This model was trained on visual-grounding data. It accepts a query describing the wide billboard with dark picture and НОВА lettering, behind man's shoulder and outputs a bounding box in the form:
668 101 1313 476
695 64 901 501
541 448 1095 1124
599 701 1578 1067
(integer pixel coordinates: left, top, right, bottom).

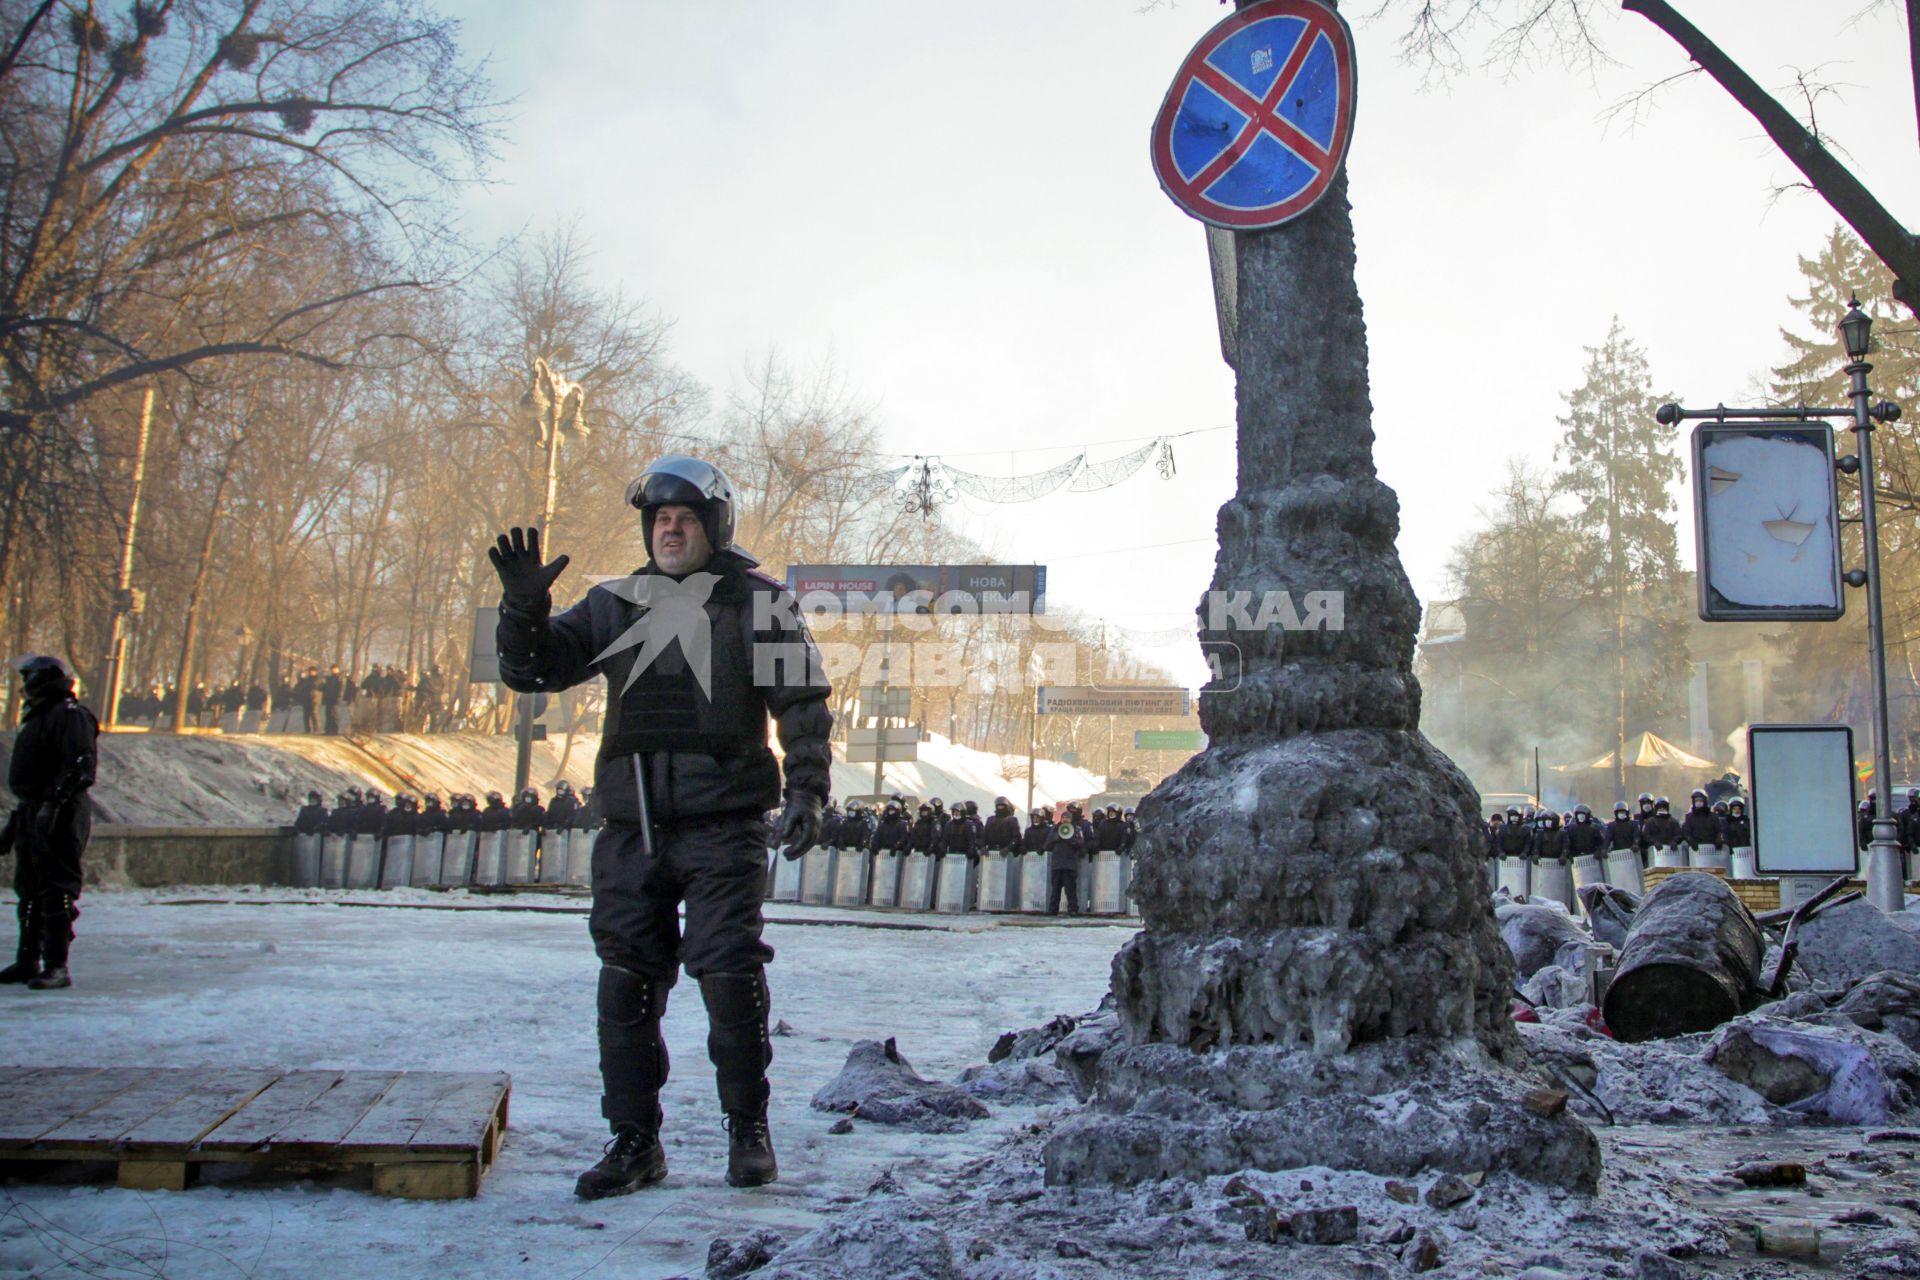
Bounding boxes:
787 564 1046 614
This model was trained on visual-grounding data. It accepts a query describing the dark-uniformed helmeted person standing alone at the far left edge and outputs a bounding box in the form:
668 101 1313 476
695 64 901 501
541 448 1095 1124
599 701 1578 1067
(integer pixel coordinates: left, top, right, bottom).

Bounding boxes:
0 654 100 990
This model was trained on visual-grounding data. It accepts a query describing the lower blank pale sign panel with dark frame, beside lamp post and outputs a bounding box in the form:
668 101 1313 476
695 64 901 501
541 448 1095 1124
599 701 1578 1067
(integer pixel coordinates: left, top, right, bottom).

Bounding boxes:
1747 723 1860 875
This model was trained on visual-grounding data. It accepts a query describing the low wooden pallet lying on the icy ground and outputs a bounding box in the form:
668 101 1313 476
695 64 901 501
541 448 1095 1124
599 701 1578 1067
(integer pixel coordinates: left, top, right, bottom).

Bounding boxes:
0 1067 513 1199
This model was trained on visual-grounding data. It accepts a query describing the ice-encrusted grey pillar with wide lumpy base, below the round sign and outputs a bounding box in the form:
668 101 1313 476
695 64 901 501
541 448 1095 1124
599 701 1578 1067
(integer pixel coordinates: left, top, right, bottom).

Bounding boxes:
1046 119 1599 1188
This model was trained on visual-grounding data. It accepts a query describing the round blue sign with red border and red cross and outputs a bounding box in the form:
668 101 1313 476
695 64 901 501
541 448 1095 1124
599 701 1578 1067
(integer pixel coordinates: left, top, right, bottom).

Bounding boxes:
1152 0 1357 230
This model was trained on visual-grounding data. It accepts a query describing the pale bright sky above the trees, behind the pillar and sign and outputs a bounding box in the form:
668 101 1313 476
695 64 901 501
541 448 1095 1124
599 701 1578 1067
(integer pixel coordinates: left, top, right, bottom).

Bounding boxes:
451 0 1916 683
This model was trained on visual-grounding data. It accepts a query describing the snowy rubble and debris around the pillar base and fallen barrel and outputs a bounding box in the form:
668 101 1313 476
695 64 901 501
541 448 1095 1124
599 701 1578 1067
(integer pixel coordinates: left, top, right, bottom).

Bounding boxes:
707 875 1920 1280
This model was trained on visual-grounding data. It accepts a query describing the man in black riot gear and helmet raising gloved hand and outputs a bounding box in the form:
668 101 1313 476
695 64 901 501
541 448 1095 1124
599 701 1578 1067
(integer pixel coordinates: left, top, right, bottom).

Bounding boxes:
490 457 833 1199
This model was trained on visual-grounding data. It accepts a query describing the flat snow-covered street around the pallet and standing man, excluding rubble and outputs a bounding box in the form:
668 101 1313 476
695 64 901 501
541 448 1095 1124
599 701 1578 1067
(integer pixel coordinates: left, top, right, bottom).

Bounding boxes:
0 889 1133 1280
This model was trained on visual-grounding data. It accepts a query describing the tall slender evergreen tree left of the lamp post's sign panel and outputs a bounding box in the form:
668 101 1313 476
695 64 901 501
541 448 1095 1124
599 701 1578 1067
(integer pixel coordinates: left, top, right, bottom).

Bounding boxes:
1553 317 1686 800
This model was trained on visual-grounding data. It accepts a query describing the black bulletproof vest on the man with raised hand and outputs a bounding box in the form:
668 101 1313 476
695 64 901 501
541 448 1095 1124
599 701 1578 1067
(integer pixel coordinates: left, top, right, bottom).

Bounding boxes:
599 572 766 760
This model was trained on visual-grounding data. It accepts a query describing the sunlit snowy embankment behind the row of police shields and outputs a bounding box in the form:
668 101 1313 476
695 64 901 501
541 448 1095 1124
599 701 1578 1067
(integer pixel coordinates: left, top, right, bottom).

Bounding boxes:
0 733 1106 827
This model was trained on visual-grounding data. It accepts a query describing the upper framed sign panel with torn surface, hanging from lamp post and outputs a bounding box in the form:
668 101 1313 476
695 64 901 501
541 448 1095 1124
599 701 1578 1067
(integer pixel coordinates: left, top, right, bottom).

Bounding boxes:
1693 422 1847 622
